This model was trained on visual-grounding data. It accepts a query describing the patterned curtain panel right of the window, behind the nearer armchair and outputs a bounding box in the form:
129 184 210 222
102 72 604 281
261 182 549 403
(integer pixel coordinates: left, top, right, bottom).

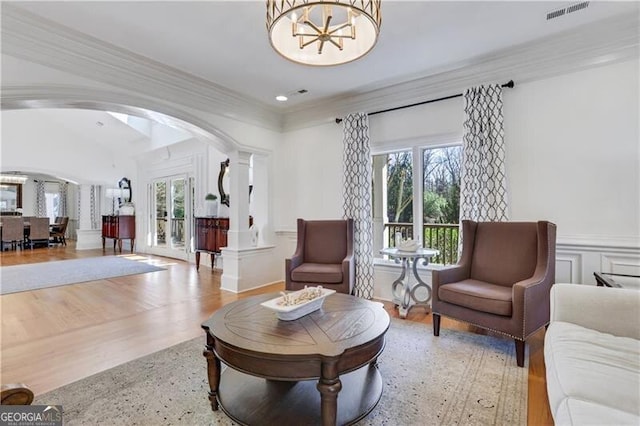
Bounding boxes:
460 85 509 223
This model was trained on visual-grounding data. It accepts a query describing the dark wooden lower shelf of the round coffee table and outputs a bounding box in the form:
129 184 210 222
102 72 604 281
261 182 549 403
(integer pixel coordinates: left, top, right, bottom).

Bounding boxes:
218 364 382 426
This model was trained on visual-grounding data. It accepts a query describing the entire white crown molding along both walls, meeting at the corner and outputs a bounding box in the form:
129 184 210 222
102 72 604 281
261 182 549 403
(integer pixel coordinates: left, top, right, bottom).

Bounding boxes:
1 2 640 131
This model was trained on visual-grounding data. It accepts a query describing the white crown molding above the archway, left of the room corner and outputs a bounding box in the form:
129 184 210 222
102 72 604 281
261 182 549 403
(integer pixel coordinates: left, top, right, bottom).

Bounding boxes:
2 3 281 130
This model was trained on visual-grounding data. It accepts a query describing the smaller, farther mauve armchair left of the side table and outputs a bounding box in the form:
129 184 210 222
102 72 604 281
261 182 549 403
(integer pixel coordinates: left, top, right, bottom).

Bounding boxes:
285 219 355 294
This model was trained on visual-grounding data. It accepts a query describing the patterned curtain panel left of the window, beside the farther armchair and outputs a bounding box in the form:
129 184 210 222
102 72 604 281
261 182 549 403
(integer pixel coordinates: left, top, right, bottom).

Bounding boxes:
342 113 373 299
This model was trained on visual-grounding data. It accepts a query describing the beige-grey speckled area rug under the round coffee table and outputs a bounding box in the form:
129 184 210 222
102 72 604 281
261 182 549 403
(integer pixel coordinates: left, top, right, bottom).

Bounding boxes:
34 319 528 426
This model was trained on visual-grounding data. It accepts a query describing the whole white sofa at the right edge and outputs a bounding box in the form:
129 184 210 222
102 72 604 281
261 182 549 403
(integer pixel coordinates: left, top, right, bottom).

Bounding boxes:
544 284 640 425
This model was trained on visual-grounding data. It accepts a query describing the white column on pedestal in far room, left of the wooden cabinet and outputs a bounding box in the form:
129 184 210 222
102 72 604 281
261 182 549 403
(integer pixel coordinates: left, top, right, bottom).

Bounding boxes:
76 185 102 250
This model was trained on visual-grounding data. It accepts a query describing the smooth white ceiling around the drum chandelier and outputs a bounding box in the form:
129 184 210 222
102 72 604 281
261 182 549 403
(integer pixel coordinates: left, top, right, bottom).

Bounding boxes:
12 0 639 110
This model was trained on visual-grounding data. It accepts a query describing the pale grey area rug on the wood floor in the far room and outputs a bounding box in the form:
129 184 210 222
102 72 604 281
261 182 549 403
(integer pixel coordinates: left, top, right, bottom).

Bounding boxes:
0 256 164 294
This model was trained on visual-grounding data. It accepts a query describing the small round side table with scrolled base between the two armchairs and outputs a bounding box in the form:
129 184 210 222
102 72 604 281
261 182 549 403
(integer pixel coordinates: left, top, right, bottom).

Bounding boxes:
380 248 440 318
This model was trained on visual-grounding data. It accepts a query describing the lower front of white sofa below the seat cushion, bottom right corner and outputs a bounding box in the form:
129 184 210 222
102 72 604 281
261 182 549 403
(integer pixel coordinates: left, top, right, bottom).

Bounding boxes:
553 398 640 426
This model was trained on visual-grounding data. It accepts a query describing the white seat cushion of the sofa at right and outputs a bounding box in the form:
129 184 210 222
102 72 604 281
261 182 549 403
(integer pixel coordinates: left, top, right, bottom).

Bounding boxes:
544 321 640 416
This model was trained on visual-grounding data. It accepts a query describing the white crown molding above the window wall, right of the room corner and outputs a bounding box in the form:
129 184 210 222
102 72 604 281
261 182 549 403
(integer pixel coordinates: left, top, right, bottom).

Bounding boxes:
283 14 640 131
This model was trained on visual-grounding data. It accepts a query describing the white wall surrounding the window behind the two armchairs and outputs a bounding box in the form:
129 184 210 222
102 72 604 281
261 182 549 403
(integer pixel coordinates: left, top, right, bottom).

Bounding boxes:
276 61 640 293
